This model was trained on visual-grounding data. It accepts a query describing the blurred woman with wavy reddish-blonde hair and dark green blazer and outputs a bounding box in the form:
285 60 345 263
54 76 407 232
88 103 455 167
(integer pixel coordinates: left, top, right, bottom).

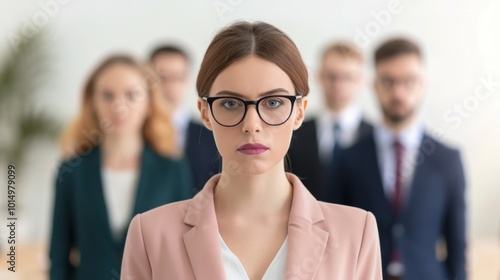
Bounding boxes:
50 55 192 280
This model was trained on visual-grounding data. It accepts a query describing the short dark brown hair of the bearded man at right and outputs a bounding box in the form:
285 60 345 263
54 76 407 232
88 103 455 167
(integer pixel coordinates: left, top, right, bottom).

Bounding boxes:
375 38 422 65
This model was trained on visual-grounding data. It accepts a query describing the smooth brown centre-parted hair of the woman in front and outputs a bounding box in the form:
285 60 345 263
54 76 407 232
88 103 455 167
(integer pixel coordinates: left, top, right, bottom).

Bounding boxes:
196 22 309 97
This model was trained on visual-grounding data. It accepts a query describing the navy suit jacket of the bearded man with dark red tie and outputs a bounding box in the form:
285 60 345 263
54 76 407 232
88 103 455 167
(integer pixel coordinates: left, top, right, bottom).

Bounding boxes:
330 134 466 280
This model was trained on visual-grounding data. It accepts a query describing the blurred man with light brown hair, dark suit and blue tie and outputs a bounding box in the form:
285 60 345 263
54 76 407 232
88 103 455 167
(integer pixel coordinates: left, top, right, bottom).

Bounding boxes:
288 42 371 200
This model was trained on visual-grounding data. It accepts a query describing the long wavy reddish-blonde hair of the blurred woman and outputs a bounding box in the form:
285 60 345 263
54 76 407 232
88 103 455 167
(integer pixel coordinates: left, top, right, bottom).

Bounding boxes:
61 55 179 158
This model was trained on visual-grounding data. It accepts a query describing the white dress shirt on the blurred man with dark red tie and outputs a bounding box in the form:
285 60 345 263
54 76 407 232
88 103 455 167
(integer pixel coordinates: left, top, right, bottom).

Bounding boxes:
374 123 424 198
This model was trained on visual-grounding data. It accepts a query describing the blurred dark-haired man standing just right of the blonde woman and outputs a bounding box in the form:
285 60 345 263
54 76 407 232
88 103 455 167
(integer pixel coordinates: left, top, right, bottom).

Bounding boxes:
150 45 220 193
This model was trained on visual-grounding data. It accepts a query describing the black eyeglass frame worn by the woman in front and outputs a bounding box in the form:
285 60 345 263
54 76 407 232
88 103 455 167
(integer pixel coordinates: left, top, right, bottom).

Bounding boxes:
201 95 304 127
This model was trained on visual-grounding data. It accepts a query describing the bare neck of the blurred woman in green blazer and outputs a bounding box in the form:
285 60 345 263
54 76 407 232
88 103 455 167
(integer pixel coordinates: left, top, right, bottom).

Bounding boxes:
101 134 144 169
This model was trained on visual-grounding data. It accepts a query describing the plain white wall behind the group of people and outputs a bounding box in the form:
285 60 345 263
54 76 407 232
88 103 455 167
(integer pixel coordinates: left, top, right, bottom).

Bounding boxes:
0 0 500 245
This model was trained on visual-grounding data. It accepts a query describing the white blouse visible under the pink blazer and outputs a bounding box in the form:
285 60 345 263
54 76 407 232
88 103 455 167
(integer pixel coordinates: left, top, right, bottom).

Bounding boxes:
219 234 288 280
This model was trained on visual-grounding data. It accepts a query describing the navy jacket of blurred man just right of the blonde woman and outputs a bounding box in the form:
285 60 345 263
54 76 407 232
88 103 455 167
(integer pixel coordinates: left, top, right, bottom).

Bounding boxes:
184 121 221 193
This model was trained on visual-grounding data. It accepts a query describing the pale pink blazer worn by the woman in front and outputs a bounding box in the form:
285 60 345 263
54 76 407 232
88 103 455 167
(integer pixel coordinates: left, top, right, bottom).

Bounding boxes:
121 173 382 280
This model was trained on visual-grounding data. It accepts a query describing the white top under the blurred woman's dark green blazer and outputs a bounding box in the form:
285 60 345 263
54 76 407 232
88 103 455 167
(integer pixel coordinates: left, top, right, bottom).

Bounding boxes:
102 168 139 240
